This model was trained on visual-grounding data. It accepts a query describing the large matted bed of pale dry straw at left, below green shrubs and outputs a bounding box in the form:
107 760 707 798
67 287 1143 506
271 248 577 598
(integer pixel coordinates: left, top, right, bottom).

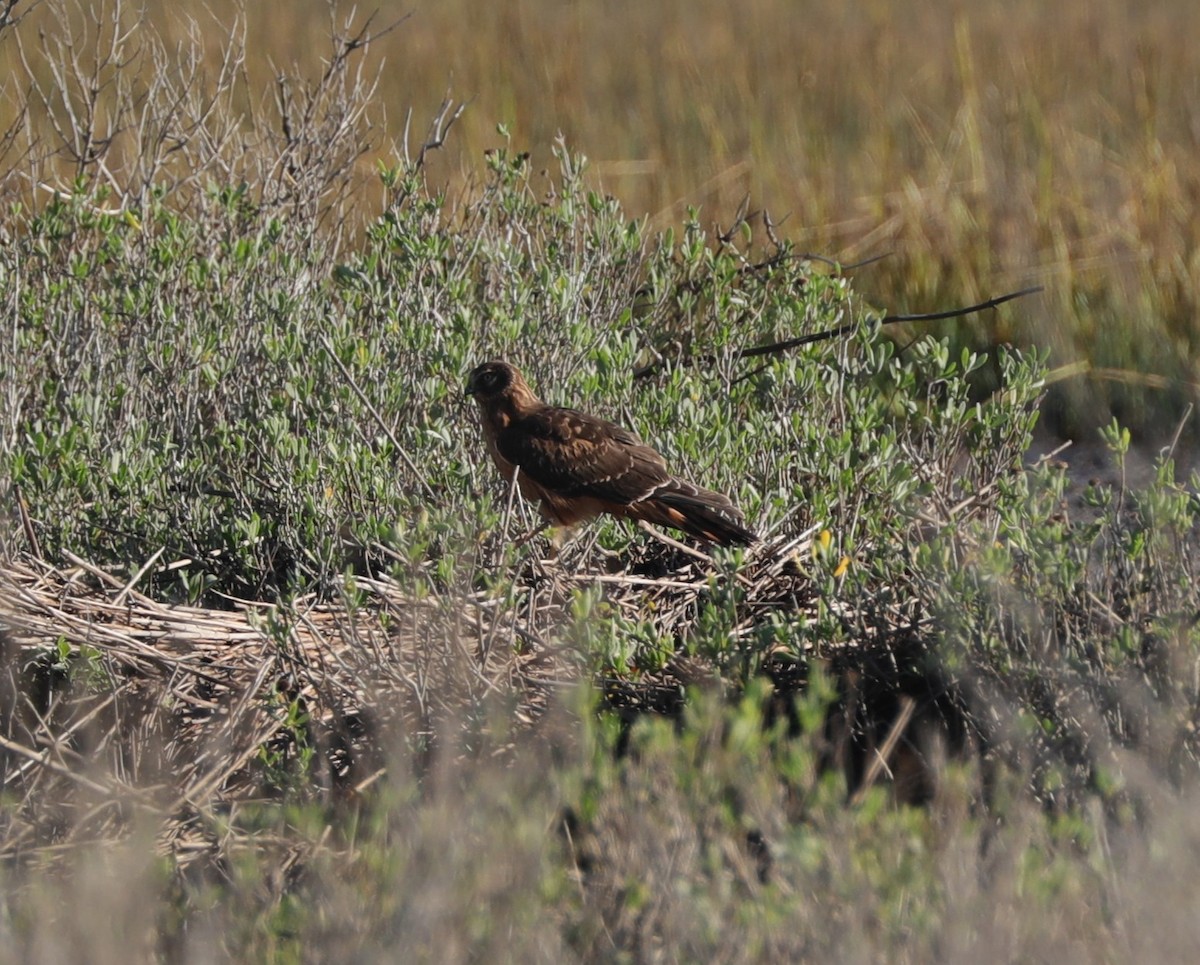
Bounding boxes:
0 549 572 865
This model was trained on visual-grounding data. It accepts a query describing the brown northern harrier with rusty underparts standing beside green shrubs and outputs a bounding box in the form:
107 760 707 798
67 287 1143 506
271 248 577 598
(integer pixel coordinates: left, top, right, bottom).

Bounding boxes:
467 361 757 546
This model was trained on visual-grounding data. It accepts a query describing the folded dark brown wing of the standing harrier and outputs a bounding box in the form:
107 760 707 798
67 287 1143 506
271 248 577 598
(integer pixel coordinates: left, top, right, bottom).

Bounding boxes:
496 406 671 505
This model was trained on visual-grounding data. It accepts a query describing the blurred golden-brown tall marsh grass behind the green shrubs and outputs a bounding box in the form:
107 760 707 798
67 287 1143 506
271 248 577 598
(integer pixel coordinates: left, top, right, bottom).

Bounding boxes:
9 0 1200 430
